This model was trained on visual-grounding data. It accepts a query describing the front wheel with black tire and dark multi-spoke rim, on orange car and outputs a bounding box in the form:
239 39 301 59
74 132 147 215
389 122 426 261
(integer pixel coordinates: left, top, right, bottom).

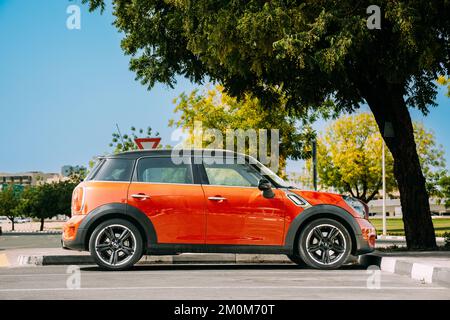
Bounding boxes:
297 218 352 270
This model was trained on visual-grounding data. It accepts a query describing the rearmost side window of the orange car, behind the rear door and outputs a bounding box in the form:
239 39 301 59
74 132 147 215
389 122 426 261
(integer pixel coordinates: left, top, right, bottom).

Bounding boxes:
92 159 134 181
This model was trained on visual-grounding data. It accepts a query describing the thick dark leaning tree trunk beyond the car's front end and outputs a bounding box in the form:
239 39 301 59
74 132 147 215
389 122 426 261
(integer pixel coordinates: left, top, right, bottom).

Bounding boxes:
366 83 436 249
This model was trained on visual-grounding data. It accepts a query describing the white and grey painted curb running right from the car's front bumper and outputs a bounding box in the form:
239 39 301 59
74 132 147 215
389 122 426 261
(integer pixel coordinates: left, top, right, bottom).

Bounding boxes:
359 254 450 287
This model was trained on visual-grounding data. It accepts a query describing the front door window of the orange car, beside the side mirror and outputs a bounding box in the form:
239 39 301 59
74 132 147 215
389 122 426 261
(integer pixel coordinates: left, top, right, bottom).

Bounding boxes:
204 163 262 187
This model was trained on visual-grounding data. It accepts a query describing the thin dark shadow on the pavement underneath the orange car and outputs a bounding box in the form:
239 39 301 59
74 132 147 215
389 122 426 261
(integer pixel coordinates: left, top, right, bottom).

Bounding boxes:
80 263 366 272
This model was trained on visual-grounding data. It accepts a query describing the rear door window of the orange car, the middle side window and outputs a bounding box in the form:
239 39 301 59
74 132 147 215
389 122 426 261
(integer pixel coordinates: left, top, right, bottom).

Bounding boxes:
137 158 193 184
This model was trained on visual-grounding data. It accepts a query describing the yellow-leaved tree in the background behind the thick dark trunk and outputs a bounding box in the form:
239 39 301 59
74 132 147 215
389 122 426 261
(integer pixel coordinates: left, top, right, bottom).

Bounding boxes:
318 113 446 202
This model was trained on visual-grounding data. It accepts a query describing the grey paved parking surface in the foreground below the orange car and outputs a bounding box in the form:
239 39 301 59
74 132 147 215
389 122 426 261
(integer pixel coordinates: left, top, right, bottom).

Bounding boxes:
0 264 450 300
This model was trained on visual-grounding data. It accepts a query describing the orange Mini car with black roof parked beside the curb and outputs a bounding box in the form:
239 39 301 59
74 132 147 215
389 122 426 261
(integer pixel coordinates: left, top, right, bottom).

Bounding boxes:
62 150 376 270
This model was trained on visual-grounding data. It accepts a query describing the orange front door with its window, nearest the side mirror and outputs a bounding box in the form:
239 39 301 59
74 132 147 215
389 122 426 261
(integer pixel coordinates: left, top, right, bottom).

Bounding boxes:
203 163 285 245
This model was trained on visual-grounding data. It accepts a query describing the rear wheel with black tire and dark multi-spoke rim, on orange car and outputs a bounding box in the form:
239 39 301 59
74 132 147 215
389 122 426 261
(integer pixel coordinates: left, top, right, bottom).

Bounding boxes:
89 219 143 270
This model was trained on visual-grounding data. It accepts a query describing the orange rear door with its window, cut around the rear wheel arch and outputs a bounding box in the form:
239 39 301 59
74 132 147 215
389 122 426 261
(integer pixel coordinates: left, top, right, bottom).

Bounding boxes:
128 157 206 244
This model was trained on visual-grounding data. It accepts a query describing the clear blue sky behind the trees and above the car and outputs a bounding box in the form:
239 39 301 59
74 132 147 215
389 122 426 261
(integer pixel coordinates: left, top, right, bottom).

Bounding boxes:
0 0 450 172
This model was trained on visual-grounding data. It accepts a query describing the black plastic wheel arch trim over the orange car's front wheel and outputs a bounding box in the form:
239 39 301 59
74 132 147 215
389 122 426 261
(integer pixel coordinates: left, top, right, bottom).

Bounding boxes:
285 204 361 254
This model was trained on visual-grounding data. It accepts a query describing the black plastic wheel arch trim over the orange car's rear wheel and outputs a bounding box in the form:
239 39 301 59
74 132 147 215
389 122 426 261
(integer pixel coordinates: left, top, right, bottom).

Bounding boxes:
77 203 157 250
